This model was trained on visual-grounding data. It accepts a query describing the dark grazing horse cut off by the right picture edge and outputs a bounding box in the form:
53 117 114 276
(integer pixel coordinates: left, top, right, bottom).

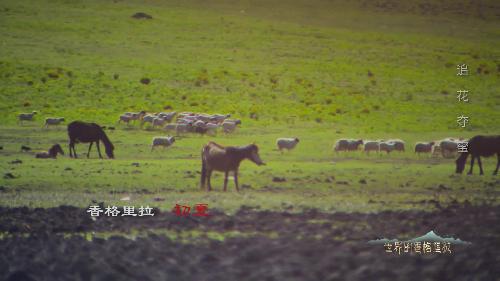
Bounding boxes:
456 135 500 175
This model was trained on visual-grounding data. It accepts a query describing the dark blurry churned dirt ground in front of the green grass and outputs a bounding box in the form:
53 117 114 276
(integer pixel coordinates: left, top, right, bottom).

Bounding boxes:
0 205 500 280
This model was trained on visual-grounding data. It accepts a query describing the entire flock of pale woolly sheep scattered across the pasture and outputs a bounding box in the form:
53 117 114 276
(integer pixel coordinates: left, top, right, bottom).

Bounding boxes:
18 111 465 158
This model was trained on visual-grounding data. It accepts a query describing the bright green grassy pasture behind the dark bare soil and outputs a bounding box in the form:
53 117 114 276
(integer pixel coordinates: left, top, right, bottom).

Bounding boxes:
0 0 500 212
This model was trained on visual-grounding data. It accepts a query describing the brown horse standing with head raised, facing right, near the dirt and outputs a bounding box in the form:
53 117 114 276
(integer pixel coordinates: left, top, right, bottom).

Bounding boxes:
201 142 265 191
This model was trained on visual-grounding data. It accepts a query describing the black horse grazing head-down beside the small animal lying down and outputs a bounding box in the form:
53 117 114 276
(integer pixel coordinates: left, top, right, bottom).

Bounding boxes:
68 121 115 158
